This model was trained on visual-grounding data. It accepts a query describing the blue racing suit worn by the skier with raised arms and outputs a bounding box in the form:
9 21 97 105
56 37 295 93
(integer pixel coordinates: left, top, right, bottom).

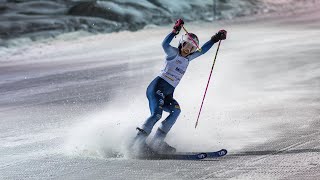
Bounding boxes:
142 33 214 142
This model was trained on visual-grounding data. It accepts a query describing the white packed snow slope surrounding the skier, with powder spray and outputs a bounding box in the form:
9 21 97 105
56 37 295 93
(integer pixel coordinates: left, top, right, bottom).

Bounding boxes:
0 3 320 179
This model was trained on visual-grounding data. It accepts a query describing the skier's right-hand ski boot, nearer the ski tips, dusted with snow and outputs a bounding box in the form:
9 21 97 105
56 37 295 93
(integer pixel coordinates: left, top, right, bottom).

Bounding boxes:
150 128 176 154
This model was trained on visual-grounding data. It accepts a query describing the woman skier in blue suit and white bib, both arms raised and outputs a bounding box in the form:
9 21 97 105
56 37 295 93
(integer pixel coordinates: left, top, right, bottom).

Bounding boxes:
134 19 227 153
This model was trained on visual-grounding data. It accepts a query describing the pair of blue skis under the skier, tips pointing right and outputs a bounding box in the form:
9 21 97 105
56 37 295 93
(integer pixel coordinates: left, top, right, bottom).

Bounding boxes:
140 149 228 160
